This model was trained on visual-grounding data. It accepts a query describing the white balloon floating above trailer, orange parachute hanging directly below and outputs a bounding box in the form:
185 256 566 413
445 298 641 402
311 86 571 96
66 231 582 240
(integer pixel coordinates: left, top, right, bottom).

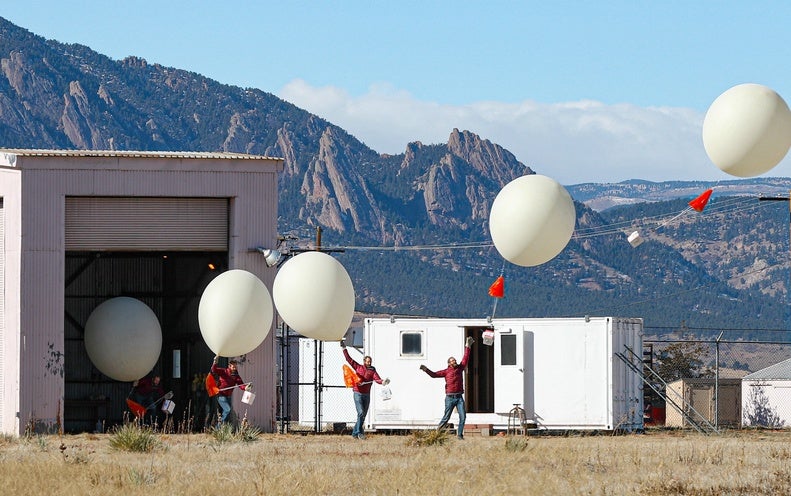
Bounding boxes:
489 174 576 267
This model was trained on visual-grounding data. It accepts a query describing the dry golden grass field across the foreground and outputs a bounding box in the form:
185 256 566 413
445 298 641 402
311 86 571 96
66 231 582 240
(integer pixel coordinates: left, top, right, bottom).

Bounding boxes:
0 431 791 496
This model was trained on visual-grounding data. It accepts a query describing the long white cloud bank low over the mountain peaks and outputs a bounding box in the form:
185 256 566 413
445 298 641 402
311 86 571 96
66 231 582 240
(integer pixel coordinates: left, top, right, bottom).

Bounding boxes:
279 80 791 184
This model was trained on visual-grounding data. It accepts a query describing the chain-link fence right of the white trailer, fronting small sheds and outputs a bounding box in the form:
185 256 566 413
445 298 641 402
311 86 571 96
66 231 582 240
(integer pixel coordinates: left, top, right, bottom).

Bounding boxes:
643 333 791 428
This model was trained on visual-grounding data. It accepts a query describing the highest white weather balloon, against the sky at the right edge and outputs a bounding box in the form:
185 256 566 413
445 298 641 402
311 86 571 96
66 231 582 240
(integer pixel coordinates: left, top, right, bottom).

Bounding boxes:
703 83 791 177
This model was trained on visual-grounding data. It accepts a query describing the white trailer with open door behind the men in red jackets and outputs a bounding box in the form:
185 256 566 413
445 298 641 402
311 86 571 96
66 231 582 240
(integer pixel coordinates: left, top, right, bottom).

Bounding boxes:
364 317 643 431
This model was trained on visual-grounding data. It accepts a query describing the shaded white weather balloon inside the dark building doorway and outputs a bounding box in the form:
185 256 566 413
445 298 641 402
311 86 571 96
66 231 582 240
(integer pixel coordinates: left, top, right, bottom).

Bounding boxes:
85 296 162 381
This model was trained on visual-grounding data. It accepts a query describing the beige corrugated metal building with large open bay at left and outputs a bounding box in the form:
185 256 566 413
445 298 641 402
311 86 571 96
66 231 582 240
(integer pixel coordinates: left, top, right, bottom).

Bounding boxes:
0 149 283 435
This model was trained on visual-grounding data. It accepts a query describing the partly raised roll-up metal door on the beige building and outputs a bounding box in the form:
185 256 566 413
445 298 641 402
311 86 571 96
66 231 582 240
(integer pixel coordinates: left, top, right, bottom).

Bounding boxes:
66 197 228 251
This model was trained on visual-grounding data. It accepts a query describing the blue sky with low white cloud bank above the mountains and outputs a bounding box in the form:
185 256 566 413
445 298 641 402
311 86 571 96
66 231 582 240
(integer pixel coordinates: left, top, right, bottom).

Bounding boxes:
0 0 791 184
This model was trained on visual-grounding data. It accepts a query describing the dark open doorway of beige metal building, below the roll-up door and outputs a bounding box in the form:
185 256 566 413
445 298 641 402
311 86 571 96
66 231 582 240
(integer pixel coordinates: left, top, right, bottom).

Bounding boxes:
64 252 228 432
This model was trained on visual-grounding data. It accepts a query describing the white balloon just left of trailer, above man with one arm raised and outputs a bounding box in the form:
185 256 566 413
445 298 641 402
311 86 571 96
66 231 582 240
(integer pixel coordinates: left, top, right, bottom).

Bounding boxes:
272 251 354 341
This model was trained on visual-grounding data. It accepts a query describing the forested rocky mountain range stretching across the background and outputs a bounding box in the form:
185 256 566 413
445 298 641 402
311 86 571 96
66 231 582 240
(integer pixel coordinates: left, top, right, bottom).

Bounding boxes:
0 18 791 334
